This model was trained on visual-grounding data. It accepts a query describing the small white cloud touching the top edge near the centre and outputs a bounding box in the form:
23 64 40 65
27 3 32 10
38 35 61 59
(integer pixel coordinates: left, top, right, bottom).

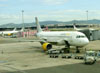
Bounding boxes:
43 0 68 5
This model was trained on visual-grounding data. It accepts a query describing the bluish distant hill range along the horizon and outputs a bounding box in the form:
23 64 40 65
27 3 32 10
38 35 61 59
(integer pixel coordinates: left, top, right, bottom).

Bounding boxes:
0 19 100 28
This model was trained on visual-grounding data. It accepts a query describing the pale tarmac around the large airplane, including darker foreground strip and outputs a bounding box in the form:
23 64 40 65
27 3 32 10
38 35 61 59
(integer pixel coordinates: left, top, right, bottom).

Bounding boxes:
0 38 100 73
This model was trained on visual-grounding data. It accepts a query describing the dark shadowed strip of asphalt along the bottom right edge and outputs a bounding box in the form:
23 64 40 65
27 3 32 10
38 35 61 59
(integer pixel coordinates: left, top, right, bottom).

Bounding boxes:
6 62 100 73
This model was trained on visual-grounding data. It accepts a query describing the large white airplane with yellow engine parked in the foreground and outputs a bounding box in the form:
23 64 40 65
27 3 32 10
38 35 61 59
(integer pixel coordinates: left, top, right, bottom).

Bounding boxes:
35 17 89 52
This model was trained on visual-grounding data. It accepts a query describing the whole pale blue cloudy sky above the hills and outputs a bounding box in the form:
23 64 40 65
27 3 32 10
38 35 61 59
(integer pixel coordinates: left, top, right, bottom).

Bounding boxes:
0 0 100 25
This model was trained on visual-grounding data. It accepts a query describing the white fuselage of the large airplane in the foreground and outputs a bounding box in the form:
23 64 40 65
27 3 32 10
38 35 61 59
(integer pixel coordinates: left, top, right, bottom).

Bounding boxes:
37 31 89 46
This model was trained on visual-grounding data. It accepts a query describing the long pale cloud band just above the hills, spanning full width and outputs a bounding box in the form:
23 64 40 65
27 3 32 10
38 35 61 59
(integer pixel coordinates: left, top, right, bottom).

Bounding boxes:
0 10 100 24
